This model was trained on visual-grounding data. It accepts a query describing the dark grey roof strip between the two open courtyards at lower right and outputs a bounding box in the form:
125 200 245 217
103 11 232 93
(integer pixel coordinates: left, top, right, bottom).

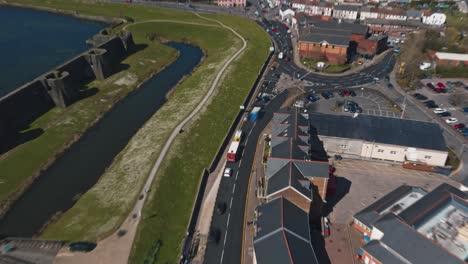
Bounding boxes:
399 183 468 226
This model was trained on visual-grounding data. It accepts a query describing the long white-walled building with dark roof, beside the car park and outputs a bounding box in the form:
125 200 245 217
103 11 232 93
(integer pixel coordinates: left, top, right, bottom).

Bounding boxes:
309 114 448 166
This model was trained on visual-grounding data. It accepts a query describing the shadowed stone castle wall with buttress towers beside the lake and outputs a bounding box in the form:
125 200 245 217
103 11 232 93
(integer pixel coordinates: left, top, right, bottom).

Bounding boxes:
0 29 135 148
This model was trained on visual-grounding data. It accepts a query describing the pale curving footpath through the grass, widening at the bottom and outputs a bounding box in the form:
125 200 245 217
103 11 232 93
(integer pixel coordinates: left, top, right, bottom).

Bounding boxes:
54 13 247 264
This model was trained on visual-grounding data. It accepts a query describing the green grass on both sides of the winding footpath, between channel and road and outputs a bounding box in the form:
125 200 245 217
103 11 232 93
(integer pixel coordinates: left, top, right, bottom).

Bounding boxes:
6 0 271 263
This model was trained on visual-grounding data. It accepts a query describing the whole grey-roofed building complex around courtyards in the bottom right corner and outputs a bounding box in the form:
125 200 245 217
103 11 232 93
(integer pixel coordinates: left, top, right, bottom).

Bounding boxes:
354 183 468 264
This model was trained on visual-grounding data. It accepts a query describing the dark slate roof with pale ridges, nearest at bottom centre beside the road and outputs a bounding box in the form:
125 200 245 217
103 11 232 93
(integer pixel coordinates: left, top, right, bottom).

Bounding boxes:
254 197 318 264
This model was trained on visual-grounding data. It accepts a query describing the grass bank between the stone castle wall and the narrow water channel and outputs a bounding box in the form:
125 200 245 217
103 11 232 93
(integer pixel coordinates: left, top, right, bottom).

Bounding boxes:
0 1 178 204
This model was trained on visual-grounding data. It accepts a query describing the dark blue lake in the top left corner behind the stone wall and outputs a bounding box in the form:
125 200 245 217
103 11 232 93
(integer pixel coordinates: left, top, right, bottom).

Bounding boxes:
0 7 105 97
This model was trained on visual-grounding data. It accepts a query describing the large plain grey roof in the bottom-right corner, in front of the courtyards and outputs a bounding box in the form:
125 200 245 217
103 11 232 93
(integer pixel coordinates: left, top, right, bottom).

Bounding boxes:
373 213 464 264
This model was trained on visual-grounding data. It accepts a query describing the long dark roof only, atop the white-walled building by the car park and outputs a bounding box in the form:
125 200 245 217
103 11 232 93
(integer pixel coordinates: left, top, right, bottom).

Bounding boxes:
309 113 447 151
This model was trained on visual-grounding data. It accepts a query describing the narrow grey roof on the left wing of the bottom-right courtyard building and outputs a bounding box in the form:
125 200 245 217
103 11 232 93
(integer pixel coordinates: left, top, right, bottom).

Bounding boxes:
354 185 425 228
